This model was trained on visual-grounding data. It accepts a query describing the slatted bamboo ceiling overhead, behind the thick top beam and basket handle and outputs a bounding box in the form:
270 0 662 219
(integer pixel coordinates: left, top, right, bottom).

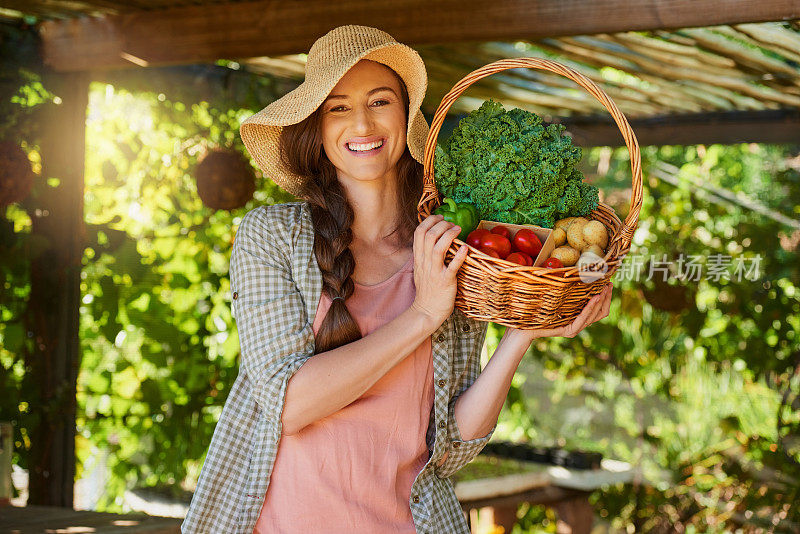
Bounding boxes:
0 0 800 123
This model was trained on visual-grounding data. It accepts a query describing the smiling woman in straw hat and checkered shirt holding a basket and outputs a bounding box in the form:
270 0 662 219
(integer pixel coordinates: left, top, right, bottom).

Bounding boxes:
182 26 610 534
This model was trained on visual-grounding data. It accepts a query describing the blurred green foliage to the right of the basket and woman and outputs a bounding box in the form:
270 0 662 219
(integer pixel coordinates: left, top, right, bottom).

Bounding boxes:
490 144 800 532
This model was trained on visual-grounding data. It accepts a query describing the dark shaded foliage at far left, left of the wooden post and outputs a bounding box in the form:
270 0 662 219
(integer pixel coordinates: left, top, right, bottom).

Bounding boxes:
0 19 58 486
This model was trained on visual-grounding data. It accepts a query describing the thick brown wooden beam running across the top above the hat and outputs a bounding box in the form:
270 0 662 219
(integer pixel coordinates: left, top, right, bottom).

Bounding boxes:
40 0 800 71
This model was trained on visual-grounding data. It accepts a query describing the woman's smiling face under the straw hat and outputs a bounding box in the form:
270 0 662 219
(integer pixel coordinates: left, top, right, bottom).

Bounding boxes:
320 60 407 189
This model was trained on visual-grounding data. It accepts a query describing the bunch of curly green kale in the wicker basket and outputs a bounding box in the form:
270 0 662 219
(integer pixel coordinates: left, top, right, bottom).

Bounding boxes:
434 100 598 228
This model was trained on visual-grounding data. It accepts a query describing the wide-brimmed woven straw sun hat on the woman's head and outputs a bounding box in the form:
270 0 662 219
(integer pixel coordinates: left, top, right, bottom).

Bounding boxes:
239 25 428 196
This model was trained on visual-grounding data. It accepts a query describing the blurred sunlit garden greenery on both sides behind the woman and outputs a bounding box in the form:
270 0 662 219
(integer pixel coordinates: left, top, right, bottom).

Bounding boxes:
0 5 800 534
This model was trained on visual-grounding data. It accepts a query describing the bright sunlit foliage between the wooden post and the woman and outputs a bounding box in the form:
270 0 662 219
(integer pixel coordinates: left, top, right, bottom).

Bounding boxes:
78 84 294 510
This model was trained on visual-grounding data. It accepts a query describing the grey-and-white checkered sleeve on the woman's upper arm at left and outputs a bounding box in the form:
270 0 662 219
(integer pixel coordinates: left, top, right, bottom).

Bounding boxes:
230 206 314 426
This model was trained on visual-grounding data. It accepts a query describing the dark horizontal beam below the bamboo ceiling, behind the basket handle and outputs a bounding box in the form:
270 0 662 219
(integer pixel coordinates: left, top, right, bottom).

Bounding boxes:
434 109 800 147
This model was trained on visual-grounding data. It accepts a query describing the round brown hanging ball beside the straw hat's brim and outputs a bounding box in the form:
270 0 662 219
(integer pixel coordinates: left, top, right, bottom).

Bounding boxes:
195 148 256 214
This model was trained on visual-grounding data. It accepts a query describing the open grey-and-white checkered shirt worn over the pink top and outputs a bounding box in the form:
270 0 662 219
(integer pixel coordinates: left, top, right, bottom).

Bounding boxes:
181 202 496 534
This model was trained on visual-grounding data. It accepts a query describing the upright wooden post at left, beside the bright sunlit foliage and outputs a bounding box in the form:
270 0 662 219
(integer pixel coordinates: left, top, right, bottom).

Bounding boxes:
26 72 89 508
